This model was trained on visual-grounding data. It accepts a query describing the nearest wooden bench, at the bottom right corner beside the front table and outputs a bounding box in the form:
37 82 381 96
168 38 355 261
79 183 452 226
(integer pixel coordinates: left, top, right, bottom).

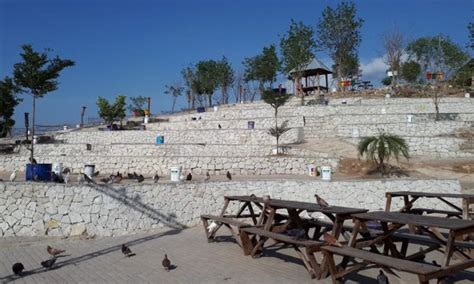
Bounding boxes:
321 246 474 283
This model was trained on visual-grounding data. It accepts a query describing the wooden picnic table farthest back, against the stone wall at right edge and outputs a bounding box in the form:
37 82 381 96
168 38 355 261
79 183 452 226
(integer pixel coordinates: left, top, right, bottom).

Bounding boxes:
385 191 474 220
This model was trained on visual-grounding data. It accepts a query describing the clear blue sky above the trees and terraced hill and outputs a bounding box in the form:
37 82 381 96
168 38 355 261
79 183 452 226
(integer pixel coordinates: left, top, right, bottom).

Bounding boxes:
0 0 473 126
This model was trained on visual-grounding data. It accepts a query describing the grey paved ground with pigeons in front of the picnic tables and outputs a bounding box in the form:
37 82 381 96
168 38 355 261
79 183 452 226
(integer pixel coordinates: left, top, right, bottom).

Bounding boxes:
0 226 474 284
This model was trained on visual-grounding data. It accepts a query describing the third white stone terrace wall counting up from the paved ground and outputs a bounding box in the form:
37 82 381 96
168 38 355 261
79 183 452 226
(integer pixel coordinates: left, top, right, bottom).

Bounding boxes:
52 127 303 145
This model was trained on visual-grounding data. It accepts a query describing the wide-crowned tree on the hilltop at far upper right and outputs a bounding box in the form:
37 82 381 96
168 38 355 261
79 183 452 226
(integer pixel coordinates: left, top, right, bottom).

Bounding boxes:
406 35 469 120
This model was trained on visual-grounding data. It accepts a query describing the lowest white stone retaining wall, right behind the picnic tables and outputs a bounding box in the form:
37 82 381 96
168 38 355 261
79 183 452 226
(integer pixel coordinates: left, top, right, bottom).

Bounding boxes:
0 179 461 237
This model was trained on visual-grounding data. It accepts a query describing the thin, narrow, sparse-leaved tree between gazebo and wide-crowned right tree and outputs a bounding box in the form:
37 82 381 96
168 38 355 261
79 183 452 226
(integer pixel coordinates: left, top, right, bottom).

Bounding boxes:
383 30 404 87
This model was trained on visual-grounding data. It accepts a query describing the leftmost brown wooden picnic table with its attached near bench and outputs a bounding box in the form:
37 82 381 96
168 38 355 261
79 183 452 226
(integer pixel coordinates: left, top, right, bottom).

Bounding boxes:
230 196 368 278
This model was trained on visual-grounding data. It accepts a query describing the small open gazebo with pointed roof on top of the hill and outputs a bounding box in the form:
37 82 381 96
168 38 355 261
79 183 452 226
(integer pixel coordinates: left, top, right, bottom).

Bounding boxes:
290 58 333 95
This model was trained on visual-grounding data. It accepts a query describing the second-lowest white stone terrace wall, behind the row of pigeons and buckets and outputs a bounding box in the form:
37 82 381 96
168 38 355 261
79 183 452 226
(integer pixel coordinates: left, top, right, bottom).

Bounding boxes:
0 152 339 176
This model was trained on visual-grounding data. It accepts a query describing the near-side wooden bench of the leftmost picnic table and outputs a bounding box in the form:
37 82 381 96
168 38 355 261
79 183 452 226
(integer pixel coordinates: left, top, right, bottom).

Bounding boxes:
240 227 324 278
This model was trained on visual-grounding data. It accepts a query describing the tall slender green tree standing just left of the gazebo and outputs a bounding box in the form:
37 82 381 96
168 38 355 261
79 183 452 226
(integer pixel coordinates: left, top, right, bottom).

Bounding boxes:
280 20 316 105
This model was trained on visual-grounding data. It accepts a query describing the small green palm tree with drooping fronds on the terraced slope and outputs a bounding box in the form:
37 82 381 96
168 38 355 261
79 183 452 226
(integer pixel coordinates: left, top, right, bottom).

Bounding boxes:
357 131 409 175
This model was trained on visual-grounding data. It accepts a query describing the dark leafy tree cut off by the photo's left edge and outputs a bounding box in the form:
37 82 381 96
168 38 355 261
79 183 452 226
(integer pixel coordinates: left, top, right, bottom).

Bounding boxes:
0 77 21 138
